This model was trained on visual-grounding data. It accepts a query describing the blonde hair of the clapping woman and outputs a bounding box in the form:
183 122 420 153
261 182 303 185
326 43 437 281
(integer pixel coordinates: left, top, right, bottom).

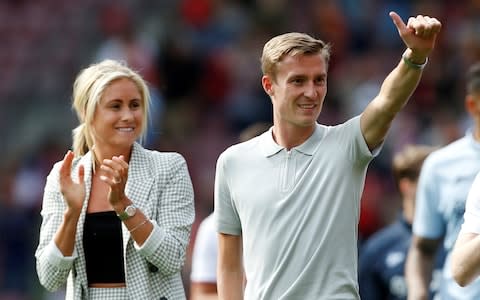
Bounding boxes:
72 59 150 156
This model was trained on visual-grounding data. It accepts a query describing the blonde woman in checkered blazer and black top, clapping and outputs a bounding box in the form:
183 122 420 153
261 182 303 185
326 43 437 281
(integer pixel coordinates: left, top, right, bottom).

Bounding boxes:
35 60 194 300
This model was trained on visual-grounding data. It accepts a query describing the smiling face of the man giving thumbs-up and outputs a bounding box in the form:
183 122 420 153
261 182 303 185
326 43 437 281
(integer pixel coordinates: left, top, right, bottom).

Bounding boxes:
262 54 327 128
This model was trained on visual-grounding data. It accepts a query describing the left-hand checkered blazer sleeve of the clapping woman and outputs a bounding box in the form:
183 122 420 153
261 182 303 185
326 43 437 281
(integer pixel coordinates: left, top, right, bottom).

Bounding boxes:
35 163 74 291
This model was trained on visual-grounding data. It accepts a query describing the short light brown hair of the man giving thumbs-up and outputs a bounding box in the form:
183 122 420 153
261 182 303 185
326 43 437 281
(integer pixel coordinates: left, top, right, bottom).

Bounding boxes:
261 32 330 79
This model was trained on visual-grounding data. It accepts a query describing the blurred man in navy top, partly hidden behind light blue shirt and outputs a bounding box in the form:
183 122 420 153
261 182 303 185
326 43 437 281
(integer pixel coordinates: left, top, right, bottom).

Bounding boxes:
358 145 443 300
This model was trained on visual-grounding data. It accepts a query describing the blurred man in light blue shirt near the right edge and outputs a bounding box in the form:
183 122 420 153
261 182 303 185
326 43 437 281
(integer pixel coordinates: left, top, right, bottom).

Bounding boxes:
406 63 480 300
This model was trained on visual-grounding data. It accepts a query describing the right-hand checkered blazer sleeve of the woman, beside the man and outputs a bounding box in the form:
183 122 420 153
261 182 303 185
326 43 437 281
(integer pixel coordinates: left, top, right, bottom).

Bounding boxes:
135 153 195 275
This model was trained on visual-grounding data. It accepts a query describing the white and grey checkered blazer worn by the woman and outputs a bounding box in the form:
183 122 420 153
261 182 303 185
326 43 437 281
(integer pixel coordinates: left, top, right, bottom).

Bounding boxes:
35 143 195 300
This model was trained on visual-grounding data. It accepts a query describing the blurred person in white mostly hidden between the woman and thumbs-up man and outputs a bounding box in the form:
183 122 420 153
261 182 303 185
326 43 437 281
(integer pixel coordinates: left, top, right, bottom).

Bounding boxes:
190 122 271 300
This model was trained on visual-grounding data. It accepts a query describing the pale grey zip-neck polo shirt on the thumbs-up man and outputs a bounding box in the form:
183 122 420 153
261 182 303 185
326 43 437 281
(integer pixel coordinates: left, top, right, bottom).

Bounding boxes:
215 116 380 300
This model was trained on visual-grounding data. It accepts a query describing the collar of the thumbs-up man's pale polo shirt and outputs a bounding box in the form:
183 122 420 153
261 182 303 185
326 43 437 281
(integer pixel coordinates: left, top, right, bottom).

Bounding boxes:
260 124 324 157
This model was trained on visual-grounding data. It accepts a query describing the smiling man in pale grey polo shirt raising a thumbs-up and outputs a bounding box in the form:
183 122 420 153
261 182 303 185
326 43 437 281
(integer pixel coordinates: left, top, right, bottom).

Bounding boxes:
215 12 441 300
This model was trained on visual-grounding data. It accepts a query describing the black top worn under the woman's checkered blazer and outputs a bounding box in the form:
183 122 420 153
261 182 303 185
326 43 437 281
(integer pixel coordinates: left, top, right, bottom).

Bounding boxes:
83 211 125 284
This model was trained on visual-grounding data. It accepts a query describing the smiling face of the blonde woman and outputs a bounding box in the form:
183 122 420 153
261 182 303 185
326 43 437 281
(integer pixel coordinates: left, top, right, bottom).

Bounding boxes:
92 78 145 153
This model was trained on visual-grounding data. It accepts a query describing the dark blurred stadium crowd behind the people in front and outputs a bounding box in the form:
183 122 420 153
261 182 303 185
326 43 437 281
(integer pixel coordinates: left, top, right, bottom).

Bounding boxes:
0 0 480 299
